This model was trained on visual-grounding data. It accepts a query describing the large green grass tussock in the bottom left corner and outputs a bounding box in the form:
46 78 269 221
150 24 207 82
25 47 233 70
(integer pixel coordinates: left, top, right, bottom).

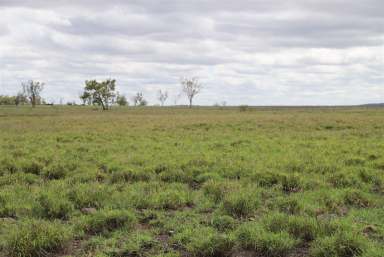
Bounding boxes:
4 220 71 257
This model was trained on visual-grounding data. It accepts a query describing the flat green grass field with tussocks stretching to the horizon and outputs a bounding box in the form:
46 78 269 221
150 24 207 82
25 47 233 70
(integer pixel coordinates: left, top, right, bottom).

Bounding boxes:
0 107 384 257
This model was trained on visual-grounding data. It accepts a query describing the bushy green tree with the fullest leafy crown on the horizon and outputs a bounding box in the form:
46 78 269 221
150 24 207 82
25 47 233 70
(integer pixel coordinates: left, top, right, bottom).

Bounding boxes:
80 79 116 110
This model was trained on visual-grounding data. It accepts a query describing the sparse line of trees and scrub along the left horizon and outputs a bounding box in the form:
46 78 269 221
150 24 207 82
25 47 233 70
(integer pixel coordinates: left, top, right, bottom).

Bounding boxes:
0 77 203 110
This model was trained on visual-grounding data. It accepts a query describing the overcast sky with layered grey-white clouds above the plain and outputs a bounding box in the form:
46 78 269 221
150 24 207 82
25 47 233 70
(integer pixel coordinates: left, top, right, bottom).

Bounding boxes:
0 0 384 105
